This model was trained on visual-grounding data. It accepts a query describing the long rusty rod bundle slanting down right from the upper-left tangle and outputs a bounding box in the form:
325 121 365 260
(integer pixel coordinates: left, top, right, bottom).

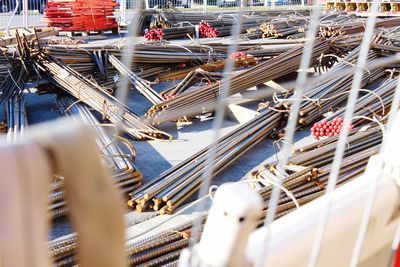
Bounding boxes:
34 52 172 140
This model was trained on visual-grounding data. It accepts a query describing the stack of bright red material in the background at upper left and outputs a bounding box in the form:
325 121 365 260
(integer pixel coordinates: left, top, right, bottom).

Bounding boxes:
44 0 118 31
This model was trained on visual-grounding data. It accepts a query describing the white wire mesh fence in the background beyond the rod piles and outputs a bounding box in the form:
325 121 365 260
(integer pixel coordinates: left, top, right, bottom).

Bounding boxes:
0 0 307 30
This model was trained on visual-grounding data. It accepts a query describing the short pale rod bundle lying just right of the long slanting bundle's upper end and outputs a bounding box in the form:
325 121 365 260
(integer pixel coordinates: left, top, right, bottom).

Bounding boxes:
108 55 163 105
